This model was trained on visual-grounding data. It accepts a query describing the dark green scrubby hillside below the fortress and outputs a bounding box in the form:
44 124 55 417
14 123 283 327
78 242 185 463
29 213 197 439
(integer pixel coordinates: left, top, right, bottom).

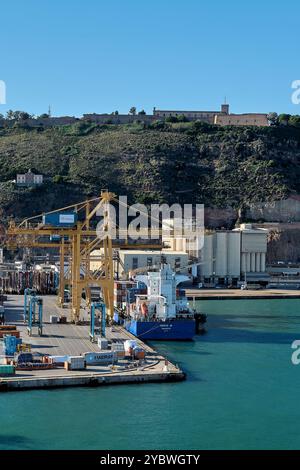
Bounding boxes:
0 122 300 225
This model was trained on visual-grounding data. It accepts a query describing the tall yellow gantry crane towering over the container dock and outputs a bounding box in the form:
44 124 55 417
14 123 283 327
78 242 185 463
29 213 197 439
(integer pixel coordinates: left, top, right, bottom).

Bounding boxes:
6 190 161 323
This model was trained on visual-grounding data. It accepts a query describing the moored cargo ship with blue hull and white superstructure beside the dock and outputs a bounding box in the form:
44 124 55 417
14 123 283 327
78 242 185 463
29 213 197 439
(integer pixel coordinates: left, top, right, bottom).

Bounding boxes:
125 265 203 340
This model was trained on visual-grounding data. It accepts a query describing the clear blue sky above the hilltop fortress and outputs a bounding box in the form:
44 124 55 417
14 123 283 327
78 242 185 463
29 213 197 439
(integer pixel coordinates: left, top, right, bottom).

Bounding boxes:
0 0 300 116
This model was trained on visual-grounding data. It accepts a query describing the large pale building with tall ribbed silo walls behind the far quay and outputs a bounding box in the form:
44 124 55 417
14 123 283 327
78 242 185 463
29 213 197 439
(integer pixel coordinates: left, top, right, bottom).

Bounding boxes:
163 224 268 287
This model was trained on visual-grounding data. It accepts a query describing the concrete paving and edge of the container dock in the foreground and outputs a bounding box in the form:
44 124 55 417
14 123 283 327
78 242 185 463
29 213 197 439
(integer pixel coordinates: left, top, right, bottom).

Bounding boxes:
0 295 185 391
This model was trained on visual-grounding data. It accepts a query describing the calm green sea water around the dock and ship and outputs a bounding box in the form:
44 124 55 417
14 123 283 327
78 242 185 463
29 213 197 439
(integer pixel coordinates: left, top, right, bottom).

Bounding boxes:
0 299 300 450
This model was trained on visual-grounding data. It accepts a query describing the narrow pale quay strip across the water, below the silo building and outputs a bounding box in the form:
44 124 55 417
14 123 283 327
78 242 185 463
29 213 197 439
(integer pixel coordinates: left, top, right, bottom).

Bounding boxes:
186 289 300 300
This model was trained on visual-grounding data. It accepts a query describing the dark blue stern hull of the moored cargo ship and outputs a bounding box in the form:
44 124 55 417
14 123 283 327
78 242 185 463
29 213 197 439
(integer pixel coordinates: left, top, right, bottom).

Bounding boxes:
125 319 196 341
